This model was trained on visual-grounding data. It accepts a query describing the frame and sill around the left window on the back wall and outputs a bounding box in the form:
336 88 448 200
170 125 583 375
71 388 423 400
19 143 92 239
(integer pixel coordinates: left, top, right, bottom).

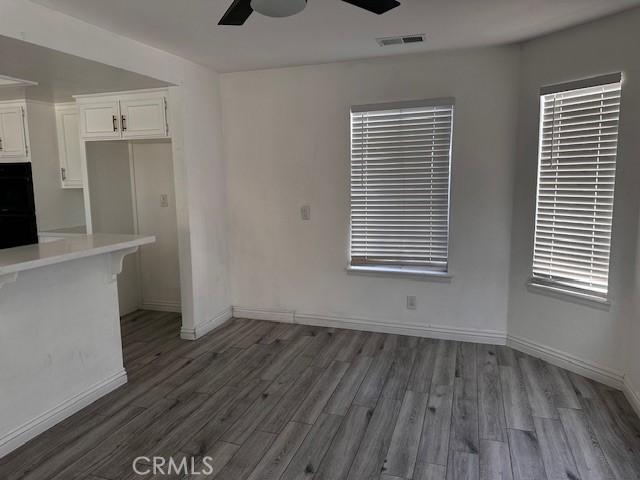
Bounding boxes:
346 97 455 282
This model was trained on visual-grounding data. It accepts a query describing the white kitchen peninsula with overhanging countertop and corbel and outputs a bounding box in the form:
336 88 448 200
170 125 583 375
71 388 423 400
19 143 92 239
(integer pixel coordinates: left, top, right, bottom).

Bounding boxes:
0 234 155 457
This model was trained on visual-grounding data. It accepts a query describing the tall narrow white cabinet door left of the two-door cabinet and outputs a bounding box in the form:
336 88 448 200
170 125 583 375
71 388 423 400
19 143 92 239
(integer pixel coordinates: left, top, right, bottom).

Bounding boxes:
56 107 82 188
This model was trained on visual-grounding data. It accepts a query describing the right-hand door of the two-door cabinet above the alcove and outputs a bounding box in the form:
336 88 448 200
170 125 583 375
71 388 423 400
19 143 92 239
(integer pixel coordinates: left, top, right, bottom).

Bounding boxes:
120 96 167 138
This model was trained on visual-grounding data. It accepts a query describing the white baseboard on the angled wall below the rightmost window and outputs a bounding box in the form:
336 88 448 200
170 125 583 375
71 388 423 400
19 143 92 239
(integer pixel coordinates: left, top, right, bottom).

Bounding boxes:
507 335 624 389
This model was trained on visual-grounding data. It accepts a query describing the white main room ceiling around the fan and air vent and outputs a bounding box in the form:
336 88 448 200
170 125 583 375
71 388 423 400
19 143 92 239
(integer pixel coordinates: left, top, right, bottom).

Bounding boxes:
27 0 640 72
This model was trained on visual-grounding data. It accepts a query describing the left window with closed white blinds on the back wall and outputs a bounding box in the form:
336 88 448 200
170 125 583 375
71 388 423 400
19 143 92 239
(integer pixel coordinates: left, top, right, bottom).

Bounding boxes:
351 99 453 273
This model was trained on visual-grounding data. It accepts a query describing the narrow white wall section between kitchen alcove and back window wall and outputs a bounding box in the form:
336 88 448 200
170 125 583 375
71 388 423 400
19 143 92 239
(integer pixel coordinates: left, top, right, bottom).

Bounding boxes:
171 74 231 338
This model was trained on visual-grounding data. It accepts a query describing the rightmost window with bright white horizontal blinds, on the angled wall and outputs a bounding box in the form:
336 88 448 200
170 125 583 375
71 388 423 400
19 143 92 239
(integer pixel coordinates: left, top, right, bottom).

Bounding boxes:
532 74 621 299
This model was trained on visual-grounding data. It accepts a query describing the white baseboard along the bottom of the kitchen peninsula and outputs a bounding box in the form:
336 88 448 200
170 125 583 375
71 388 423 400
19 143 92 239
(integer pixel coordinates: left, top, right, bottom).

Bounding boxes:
0 368 127 458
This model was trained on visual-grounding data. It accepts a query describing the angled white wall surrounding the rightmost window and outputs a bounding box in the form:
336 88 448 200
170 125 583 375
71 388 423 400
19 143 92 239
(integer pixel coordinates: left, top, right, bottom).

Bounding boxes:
509 9 640 378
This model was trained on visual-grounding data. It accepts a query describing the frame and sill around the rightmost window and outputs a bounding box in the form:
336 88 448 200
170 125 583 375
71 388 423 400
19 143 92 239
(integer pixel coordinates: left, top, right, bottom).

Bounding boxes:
527 72 623 307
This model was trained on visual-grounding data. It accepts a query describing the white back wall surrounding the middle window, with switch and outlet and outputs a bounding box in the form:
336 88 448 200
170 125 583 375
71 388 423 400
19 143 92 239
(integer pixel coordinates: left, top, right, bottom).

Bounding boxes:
222 47 518 336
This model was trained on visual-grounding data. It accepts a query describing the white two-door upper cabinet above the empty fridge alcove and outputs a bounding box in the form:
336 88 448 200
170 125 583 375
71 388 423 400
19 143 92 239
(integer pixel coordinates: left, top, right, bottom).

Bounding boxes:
76 90 169 141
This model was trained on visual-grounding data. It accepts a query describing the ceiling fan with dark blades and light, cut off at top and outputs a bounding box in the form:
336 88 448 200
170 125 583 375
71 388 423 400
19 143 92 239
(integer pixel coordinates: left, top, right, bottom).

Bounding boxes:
218 0 400 25
